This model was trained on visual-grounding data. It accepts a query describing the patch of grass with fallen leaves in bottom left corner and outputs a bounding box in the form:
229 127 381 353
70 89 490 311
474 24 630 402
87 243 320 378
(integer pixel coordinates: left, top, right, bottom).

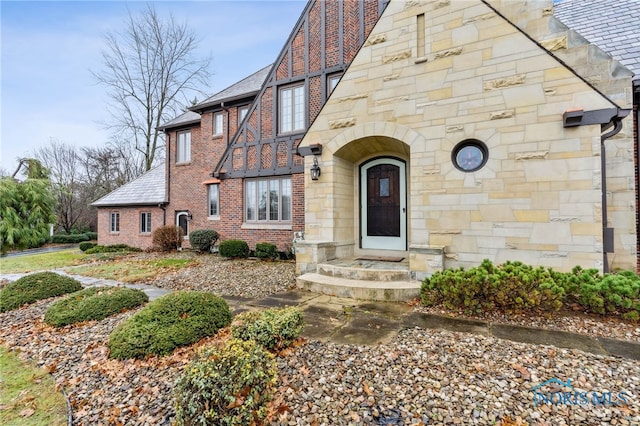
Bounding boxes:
0 346 67 426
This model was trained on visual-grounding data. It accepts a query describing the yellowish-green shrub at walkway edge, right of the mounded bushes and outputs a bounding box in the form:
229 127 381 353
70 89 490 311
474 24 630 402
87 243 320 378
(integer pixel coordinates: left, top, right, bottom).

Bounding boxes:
231 306 304 351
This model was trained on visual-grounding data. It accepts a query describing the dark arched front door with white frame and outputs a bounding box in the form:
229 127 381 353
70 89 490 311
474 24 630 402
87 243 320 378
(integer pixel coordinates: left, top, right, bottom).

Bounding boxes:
360 157 407 250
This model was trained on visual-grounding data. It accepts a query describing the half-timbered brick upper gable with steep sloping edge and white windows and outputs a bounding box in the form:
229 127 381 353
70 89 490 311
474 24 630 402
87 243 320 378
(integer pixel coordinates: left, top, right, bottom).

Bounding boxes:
214 0 388 179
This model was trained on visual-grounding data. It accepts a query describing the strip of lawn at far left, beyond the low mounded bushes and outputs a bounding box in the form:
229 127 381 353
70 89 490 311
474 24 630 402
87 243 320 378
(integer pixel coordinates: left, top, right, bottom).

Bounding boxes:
0 248 89 274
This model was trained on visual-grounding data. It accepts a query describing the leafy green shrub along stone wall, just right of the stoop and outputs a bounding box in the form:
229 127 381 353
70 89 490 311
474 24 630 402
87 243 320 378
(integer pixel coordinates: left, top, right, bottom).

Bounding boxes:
421 259 564 313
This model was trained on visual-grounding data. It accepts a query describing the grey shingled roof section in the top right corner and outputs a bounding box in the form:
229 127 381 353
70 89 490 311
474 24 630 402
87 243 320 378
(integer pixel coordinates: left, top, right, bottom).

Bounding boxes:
554 0 640 80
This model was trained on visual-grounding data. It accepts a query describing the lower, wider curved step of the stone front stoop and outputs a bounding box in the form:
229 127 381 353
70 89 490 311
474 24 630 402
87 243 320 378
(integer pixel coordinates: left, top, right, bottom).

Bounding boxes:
296 272 421 302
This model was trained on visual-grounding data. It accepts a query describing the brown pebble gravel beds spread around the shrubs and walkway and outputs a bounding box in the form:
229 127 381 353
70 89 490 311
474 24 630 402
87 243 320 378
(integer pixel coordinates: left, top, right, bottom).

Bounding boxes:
0 254 640 425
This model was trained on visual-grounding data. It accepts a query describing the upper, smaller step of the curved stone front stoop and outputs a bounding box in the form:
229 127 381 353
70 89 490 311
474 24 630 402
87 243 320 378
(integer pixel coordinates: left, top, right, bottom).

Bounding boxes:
317 259 411 281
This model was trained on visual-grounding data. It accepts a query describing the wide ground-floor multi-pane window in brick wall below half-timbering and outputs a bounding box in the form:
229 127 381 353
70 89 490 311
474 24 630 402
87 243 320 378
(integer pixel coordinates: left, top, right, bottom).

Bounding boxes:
245 177 291 222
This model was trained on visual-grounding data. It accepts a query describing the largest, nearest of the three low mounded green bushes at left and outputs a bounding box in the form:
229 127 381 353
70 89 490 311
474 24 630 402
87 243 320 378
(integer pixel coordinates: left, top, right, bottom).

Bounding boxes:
108 291 231 359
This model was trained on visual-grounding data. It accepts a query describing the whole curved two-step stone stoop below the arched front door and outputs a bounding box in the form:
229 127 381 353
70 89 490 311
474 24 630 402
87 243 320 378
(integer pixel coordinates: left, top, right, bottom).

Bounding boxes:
296 259 421 302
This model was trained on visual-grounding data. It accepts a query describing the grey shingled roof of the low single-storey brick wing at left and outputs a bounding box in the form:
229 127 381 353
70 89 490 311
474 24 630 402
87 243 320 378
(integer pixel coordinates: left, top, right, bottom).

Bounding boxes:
91 164 167 207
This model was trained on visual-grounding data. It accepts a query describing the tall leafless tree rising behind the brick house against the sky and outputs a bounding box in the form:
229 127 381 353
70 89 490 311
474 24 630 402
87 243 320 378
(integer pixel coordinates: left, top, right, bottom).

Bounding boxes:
93 5 210 170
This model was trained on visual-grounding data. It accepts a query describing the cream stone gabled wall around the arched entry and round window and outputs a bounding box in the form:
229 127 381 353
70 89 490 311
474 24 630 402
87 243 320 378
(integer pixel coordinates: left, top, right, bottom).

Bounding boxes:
299 0 636 278
